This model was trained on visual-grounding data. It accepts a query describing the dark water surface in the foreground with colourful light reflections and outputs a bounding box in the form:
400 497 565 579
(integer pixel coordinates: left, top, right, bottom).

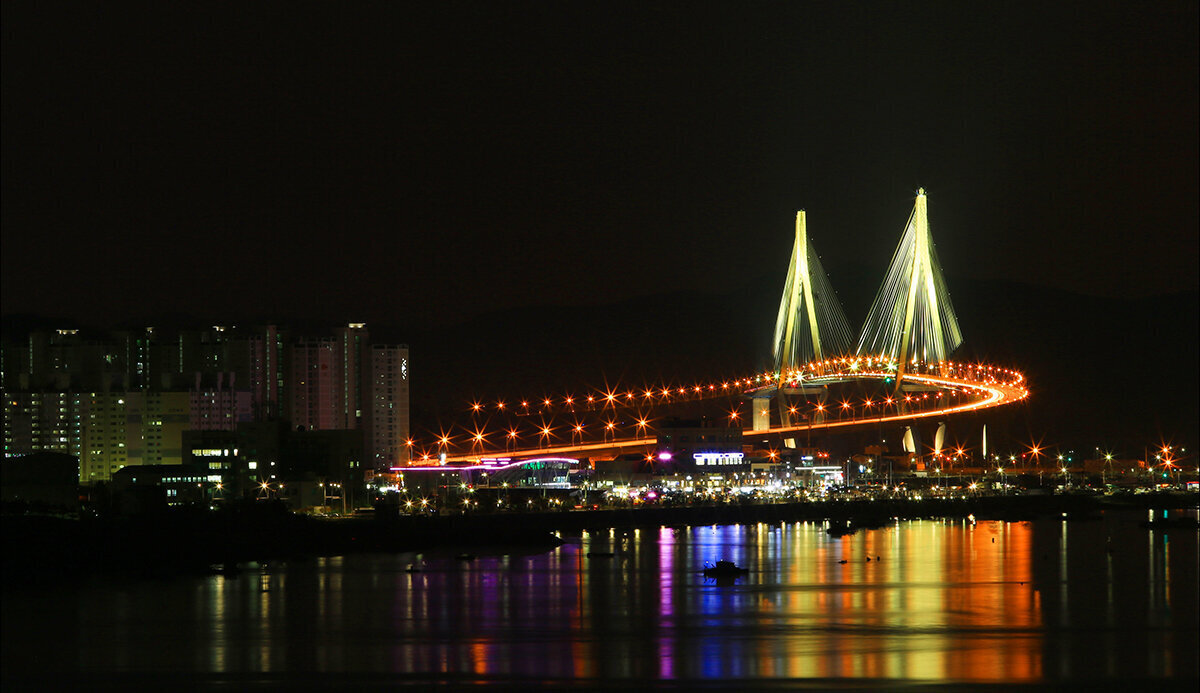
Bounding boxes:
4 503 1200 682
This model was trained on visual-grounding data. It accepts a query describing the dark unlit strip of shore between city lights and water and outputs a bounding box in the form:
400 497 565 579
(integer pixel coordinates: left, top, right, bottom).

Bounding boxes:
2 493 1200 586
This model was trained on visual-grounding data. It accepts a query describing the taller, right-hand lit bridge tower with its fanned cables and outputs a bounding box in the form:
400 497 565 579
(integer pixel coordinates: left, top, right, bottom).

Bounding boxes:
858 188 962 387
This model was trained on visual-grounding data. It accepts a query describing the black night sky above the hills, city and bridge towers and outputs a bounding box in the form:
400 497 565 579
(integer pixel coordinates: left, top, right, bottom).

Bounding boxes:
2 1 1200 327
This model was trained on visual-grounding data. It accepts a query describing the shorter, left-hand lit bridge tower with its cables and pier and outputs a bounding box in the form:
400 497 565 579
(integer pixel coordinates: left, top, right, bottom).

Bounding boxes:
755 210 853 429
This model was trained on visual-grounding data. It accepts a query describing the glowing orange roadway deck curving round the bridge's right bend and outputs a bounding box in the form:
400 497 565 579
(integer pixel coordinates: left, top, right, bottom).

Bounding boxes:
446 370 1030 464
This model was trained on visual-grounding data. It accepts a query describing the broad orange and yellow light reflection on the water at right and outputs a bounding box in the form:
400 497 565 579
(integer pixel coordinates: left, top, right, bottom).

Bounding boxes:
691 520 1042 682
